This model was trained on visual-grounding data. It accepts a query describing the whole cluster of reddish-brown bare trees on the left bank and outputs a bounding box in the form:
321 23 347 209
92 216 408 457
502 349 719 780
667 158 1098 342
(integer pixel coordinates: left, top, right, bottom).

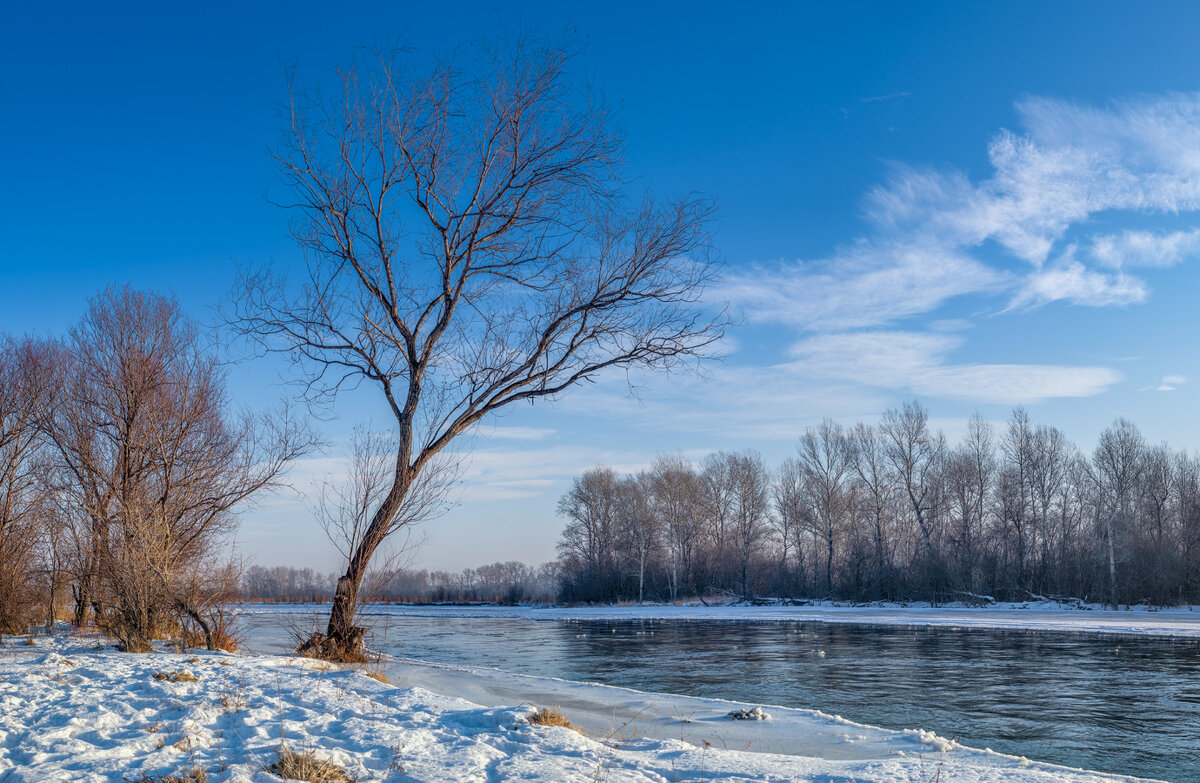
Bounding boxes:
0 288 312 651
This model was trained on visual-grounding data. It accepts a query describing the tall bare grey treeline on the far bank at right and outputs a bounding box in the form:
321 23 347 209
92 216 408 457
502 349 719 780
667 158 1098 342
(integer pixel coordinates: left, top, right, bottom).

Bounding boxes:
558 402 1200 605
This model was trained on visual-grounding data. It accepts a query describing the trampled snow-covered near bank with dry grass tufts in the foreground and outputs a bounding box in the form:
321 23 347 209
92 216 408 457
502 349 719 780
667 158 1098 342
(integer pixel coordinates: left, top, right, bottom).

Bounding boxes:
0 636 1161 783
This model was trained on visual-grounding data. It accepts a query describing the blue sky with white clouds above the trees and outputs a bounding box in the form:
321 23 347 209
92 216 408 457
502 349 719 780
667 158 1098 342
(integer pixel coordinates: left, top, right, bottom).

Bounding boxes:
0 2 1200 569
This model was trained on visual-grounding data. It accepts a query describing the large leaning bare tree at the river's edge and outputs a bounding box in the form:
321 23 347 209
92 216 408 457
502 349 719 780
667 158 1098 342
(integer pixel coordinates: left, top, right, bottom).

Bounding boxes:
236 41 722 655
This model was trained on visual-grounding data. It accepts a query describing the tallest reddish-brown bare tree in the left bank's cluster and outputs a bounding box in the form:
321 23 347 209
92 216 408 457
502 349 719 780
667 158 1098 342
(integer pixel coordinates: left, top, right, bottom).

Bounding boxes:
48 288 311 651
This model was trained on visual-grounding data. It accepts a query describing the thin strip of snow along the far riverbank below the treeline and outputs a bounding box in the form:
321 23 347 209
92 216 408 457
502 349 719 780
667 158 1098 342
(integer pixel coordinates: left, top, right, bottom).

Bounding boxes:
241 602 1200 639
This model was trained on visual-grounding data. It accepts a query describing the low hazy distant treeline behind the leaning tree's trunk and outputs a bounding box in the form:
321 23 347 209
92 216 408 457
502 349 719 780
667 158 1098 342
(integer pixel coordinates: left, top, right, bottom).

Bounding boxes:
239 561 559 604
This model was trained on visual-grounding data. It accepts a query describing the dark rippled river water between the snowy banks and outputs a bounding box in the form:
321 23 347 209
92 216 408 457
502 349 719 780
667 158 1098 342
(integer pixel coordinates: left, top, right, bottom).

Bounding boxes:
244 614 1200 783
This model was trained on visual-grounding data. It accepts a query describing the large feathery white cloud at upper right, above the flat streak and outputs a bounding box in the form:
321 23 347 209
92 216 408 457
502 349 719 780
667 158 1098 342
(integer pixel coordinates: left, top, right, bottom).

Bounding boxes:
724 94 1200 331
